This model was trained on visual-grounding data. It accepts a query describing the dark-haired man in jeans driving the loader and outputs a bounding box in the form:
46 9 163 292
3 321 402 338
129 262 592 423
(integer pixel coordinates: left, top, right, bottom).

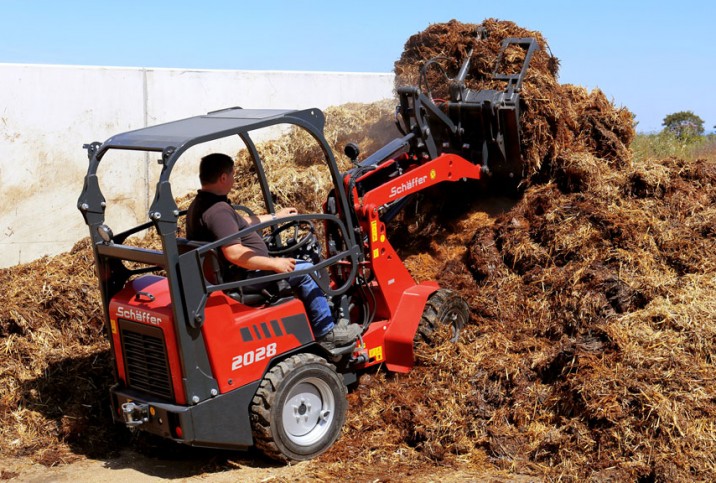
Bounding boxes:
186 153 361 350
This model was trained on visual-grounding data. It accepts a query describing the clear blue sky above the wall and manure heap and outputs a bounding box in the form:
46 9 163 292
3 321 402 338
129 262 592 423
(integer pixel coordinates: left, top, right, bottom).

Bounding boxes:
0 0 716 132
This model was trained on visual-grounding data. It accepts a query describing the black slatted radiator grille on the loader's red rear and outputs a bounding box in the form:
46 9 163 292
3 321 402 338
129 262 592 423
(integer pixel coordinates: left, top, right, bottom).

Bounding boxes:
119 320 173 400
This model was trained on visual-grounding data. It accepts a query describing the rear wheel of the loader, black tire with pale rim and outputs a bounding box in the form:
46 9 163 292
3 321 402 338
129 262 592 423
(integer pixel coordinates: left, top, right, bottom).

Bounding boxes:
251 354 348 462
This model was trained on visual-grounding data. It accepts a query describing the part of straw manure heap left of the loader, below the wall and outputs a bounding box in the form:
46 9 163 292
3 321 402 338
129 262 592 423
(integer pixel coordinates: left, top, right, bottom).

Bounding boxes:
0 240 120 465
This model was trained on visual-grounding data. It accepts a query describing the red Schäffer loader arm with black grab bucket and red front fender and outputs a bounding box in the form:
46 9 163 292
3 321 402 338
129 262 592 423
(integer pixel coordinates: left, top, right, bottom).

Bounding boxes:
343 38 537 371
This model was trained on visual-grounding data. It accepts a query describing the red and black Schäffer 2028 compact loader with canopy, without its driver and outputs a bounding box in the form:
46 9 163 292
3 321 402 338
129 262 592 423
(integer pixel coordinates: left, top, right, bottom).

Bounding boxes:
78 35 536 461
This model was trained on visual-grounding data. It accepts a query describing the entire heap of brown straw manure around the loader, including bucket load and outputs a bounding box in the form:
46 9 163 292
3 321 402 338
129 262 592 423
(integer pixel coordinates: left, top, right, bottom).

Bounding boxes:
0 20 716 481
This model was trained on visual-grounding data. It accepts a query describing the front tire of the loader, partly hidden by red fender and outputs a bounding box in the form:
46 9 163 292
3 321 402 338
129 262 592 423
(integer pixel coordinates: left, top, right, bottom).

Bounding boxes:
415 289 470 347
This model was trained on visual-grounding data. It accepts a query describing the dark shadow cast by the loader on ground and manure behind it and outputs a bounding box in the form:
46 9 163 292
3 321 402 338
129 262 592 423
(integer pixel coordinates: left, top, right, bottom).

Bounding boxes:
18 350 280 478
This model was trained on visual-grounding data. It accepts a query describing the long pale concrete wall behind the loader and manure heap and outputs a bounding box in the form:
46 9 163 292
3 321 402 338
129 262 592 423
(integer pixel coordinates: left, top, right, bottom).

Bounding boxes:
0 64 393 267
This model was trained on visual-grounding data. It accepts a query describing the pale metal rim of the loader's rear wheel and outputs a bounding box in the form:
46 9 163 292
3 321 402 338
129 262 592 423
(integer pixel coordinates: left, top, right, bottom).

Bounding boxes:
282 377 336 446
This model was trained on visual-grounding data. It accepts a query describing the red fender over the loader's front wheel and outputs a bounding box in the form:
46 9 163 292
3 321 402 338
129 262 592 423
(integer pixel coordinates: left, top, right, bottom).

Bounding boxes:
384 282 440 373
